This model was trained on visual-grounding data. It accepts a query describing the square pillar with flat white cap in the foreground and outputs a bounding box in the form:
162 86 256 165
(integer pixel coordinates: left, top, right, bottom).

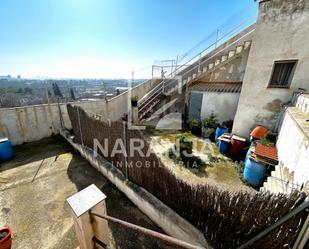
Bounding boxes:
67 184 109 249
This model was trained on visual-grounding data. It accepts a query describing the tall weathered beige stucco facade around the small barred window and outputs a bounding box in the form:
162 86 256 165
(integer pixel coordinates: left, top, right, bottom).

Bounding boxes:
233 0 309 137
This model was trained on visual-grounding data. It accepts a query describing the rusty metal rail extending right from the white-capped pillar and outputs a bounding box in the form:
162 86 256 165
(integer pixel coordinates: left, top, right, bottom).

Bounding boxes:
89 210 204 249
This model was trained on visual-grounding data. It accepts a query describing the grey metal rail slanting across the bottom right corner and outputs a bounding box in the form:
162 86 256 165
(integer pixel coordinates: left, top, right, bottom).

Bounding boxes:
237 197 309 249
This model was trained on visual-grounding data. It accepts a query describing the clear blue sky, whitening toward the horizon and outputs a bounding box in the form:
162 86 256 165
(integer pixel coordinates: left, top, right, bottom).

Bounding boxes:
0 0 257 78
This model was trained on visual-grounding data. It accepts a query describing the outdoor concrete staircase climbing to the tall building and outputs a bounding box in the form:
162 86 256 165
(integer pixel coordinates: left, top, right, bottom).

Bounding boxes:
138 25 255 120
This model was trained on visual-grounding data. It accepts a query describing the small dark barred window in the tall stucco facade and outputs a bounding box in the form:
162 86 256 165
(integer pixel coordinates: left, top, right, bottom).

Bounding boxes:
268 60 297 87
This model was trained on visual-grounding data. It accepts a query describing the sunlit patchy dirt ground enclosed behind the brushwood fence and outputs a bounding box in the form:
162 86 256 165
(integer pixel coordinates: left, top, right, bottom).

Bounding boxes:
151 132 254 191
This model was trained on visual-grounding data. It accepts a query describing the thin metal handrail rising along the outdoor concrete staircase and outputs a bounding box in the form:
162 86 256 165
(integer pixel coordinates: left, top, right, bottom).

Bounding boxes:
139 16 253 110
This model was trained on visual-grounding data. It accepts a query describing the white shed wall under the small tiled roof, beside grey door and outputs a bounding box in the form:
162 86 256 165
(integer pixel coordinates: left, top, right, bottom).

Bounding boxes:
201 92 240 123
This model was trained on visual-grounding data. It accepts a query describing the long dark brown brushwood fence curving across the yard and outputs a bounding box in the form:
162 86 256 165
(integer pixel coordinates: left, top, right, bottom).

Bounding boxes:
68 105 305 249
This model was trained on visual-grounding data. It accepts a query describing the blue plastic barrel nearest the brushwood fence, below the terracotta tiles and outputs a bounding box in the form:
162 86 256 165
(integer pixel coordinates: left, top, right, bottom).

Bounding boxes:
244 158 266 187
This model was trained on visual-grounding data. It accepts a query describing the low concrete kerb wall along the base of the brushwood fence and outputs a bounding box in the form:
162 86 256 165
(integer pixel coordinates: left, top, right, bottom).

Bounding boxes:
61 129 207 248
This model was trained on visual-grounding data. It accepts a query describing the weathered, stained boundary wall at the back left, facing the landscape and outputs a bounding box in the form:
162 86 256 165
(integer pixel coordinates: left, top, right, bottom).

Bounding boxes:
0 80 158 145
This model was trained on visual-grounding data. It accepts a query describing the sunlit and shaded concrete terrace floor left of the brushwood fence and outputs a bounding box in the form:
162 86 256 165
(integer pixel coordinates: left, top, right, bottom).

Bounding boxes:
0 137 169 249
